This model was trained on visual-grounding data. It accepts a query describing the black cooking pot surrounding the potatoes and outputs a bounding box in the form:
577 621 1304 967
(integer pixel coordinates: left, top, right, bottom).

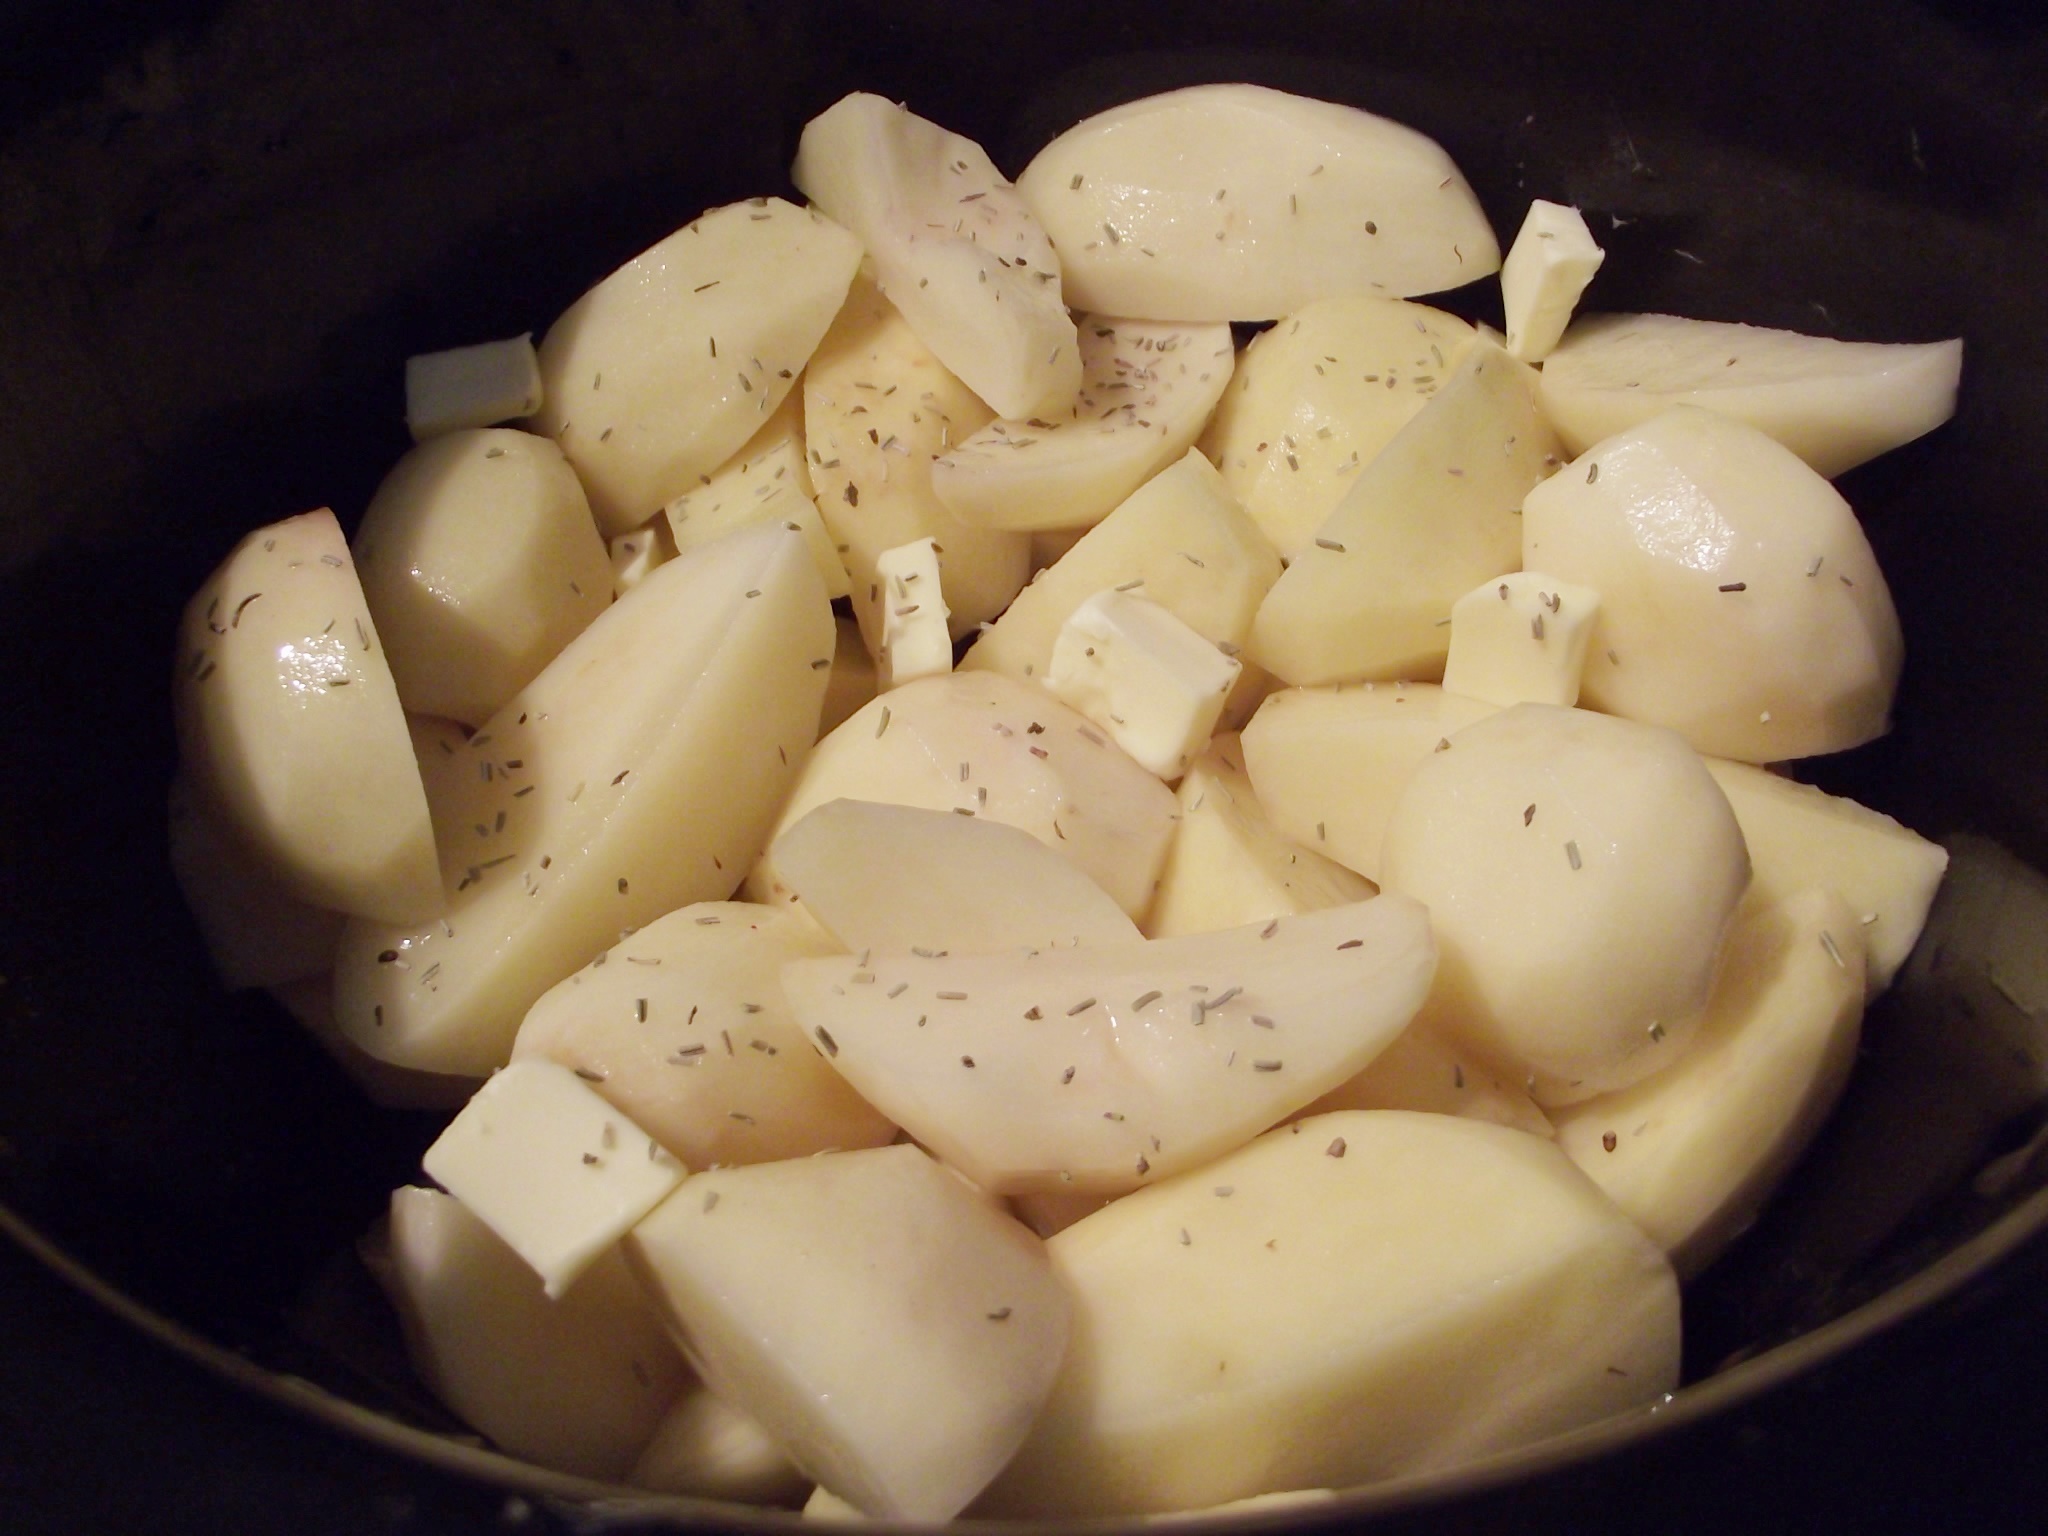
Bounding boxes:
0 0 2048 1532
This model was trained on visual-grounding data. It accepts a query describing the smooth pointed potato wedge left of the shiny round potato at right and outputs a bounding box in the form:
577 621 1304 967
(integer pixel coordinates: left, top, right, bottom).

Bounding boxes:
1245 338 1556 684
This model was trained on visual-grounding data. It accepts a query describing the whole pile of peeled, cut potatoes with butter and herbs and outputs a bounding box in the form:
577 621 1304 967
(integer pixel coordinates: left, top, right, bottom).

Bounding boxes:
170 86 1960 1520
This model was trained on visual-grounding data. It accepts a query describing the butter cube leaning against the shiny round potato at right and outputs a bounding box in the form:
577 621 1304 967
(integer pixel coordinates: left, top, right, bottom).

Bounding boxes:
1444 571 1599 707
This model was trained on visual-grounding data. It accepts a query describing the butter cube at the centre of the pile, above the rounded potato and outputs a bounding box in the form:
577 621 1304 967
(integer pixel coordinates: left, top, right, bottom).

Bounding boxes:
1047 590 1243 778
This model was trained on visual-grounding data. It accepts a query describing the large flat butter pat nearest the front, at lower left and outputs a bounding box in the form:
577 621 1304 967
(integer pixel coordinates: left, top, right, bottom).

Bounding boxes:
422 1059 688 1296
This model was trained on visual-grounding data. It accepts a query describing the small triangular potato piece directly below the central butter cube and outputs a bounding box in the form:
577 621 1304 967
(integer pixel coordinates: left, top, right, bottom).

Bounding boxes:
1145 735 1372 938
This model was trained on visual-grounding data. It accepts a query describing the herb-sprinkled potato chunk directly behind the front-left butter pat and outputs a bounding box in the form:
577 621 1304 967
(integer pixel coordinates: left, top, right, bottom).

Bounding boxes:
512 901 895 1167
